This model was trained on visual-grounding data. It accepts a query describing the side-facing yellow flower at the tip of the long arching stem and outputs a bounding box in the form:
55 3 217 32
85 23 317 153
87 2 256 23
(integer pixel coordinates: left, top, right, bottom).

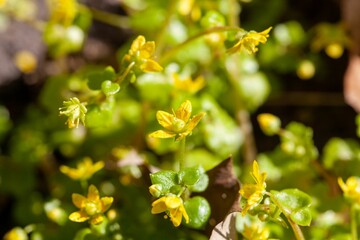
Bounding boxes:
227 27 272 54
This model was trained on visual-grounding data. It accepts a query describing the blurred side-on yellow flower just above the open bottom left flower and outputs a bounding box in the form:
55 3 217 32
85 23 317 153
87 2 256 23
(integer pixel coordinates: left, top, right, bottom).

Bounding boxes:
60 157 104 180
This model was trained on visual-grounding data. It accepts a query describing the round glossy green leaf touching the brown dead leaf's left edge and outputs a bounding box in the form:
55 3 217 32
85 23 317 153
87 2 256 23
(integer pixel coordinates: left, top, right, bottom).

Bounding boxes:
184 196 211 229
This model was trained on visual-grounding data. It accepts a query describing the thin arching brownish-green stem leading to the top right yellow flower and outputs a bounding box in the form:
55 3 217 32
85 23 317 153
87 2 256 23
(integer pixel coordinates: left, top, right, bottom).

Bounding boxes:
160 26 244 63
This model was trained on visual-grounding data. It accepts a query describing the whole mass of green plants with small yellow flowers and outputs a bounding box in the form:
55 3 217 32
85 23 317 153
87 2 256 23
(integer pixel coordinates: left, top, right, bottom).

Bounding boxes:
0 0 360 240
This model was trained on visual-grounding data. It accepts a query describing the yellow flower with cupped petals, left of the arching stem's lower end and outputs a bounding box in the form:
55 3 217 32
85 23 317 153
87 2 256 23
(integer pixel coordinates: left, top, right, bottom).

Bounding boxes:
124 35 163 72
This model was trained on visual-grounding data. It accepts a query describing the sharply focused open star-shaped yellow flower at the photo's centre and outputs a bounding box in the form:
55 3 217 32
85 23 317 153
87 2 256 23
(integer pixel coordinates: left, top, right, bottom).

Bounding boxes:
149 100 205 141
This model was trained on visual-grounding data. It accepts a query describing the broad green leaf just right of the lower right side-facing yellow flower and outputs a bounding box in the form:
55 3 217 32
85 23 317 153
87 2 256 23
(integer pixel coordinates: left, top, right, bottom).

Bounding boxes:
271 188 312 226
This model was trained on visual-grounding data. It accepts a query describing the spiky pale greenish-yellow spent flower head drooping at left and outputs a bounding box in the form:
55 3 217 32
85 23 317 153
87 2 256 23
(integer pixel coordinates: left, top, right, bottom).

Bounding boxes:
59 97 87 128
